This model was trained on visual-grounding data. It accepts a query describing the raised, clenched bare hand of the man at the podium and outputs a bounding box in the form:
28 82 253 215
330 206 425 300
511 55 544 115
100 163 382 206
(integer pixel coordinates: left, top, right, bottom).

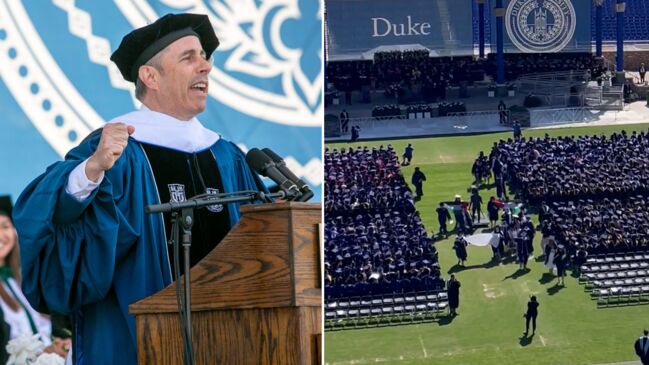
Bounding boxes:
86 123 135 182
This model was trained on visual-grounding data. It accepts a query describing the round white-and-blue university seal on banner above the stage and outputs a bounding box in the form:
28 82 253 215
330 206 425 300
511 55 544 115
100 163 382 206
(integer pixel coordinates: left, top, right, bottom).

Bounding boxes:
505 0 577 53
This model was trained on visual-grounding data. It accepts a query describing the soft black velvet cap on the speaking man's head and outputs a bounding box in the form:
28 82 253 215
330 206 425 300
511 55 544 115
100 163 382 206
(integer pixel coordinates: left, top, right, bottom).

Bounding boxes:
110 14 219 82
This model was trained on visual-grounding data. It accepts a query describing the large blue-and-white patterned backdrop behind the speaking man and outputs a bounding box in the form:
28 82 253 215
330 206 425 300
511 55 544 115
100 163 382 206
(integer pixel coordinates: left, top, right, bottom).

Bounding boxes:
0 0 324 200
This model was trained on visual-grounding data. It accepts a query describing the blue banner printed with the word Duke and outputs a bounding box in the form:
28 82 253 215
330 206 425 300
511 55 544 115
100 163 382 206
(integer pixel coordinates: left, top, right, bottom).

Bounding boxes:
326 0 473 60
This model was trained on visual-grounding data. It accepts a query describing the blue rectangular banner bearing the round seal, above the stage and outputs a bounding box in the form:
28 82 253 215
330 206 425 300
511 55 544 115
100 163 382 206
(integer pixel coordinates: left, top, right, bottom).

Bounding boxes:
491 0 592 53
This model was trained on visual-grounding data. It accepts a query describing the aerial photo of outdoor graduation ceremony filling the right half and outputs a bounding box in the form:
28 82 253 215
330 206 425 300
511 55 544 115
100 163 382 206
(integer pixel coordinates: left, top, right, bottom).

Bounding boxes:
323 0 649 365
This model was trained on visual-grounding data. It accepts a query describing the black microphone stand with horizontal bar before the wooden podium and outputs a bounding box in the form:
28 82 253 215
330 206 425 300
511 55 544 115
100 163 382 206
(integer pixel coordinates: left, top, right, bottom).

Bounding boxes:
144 191 293 365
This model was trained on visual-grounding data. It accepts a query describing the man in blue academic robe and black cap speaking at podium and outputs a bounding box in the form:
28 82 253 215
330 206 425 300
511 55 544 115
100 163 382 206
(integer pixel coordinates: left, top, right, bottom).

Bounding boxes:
14 14 265 365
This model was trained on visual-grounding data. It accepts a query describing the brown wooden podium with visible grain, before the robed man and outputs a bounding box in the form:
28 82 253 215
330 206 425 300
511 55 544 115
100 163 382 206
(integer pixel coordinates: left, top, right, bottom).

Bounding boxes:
129 202 322 365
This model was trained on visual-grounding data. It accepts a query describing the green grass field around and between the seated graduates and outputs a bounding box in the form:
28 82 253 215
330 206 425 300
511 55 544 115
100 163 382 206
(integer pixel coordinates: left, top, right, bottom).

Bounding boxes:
325 124 649 365
